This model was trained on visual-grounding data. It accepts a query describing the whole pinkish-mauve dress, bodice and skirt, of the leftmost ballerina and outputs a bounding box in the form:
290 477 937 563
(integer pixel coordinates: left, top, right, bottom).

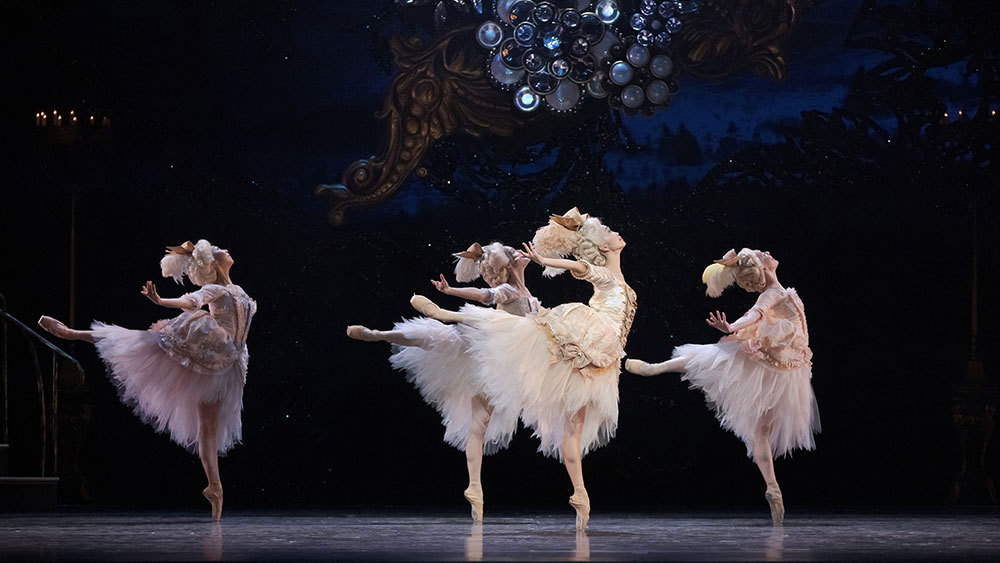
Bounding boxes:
91 285 256 453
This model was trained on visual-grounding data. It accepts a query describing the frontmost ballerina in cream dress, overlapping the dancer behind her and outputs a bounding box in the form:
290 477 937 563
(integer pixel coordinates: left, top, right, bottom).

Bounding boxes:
411 208 636 530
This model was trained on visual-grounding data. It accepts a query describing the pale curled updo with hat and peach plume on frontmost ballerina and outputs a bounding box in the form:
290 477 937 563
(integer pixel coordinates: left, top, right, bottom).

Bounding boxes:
531 207 608 277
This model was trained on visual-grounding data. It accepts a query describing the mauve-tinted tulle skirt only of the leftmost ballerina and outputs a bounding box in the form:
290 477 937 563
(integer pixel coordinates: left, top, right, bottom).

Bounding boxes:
90 322 245 454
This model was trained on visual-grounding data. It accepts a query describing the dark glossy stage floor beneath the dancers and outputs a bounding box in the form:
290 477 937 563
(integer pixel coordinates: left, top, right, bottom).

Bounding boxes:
0 510 1000 561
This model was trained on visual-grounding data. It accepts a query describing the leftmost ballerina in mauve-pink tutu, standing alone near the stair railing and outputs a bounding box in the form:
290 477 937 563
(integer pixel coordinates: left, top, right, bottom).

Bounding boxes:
38 240 257 520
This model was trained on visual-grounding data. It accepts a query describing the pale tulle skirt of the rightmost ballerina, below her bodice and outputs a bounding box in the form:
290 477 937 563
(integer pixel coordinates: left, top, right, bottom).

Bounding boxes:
673 341 820 458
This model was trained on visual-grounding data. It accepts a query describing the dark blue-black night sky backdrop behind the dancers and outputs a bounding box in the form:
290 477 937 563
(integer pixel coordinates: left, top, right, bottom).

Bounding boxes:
0 0 1000 511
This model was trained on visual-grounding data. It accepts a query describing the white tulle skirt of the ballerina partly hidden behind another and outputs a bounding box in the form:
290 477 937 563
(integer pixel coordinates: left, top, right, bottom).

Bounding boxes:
389 312 518 454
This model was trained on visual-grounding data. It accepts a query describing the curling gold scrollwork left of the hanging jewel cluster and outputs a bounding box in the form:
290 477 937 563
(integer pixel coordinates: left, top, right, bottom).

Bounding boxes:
316 26 524 225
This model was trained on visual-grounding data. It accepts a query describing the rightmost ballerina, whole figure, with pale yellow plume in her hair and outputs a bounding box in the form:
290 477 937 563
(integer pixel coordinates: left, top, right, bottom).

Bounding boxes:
625 248 820 524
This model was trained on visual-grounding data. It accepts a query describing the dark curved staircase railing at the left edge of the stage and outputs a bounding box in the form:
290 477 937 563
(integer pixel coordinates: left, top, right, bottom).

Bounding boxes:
0 294 84 477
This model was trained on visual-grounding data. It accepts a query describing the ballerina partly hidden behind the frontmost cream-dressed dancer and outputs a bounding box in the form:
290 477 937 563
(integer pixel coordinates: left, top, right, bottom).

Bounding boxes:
347 242 538 522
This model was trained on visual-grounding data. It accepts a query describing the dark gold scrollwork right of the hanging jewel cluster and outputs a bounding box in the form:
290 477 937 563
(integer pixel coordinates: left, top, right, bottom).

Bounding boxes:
674 0 804 80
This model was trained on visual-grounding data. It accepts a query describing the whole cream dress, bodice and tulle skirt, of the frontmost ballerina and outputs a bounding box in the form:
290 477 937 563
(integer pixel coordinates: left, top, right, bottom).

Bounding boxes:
459 266 635 459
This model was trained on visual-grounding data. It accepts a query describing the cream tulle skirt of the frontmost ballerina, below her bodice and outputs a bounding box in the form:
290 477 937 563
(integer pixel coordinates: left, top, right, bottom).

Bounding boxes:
458 306 619 460
